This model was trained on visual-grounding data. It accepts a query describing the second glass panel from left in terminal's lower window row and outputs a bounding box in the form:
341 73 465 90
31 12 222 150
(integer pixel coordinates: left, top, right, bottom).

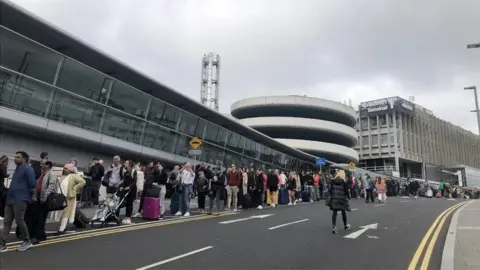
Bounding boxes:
48 90 104 132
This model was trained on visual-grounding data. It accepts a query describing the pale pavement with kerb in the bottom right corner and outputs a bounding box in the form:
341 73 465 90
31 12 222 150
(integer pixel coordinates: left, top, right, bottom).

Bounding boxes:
441 200 480 270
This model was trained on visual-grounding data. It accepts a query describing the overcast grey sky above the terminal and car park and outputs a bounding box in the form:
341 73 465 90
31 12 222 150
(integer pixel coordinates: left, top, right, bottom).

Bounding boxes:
9 0 480 133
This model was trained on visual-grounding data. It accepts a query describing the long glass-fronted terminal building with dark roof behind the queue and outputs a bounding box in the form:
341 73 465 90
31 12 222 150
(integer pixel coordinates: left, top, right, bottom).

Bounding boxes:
0 0 315 170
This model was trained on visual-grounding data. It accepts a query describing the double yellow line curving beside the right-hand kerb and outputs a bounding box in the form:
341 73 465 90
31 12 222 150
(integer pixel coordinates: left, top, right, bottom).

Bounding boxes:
408 202 466 270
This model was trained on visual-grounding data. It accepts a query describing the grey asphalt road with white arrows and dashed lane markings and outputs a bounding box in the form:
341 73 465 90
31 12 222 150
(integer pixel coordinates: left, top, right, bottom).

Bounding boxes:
0 197 459 270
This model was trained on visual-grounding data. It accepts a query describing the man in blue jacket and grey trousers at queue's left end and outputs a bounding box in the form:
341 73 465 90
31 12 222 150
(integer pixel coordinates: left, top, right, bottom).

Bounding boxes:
0 151 36 252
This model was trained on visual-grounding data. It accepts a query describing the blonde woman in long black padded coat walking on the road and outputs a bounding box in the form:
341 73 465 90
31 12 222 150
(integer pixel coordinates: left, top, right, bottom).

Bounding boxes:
328 170 350 234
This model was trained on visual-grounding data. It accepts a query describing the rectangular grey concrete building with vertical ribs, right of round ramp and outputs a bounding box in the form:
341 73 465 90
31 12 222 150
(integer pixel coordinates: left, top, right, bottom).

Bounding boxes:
356 97 480 185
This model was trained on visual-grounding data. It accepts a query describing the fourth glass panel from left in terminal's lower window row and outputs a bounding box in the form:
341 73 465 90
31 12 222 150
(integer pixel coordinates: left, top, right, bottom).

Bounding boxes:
143 123 176 153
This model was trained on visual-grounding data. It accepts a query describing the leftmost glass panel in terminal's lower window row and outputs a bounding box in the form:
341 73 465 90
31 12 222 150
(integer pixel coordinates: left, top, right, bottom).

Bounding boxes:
0 69 53 117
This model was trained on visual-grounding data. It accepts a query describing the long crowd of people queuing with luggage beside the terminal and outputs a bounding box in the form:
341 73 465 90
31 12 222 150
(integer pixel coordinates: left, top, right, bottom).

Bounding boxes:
0 151 478 251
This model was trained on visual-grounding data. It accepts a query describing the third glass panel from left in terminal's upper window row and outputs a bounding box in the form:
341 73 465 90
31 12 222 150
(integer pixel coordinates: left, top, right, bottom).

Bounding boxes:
108 82 149 118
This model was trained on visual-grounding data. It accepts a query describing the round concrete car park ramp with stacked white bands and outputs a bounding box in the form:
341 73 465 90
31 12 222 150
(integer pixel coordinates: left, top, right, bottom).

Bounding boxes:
231 96 358 163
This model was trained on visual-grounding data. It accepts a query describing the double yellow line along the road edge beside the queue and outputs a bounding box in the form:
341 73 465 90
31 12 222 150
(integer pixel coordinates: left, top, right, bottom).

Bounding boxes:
3 212 236 251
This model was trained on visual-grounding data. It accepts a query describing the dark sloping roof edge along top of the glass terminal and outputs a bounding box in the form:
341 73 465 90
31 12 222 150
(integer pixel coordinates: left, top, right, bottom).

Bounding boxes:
0 0 315 163
